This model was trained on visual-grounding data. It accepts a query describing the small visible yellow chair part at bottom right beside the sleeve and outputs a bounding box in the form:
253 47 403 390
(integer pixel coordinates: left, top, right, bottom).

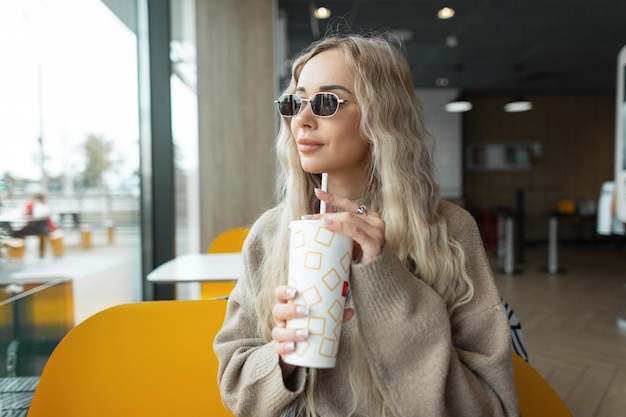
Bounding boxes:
513 353 572 417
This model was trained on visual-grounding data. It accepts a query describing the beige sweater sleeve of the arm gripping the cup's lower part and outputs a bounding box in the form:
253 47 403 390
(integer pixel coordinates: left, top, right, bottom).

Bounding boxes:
213 213 306 417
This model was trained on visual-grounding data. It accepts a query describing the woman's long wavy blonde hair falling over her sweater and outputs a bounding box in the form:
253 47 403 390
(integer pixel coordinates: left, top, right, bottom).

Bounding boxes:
256 34 474 416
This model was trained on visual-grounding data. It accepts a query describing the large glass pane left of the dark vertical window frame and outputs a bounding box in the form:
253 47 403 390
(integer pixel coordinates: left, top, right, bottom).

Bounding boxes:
0 0 141 392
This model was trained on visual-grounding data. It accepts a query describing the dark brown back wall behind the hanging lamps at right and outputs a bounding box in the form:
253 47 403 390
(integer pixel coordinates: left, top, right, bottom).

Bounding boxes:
463 95 615 241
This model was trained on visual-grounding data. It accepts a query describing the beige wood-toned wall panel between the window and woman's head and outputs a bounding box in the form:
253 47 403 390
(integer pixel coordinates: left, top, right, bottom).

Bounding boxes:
196 0 277 250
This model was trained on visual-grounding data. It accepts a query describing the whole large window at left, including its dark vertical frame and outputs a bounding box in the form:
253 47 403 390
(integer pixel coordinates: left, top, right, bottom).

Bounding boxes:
0 0 201 404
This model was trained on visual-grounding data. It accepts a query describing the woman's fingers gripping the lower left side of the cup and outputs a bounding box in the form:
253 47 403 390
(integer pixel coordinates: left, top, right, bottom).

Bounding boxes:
272 285 309 355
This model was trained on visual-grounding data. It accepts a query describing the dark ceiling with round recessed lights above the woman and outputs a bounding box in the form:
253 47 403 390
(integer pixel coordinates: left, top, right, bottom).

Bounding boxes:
278 0 626 94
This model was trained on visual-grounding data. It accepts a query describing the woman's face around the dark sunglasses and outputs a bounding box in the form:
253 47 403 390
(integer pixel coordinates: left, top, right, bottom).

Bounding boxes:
291 49 370 181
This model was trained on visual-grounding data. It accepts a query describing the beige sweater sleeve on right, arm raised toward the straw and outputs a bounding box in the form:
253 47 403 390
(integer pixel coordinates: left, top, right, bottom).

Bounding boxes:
351 204 519 417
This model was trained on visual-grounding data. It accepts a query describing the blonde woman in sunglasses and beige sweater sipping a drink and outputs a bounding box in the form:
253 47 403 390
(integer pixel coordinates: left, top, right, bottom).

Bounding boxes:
214 35 518 417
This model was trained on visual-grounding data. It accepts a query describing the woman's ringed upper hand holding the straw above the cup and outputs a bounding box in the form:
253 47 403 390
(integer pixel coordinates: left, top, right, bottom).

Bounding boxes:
306 188 385 263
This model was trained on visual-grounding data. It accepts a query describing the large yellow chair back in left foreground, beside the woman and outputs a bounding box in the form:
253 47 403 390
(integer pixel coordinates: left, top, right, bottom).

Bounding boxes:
28 300 232 417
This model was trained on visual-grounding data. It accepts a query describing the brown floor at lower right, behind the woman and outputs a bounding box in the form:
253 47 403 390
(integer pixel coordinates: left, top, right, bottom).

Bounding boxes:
492 242 626 417
